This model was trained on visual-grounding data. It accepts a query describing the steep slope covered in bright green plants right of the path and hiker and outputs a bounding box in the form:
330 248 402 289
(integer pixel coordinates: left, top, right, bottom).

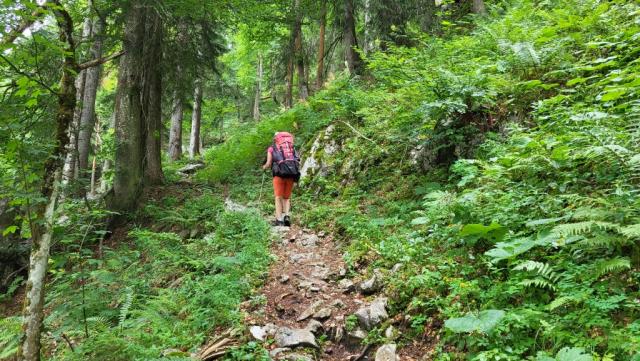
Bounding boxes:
200 0 640 360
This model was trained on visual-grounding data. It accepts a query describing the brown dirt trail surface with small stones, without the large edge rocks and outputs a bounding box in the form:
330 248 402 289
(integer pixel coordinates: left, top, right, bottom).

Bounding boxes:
242 226 367 361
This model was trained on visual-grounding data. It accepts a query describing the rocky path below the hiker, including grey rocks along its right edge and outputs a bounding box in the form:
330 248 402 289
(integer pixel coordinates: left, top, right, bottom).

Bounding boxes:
240 227 404 361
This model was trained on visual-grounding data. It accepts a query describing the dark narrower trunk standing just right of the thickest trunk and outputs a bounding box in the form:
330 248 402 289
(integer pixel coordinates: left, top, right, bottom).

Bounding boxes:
144 11 164 185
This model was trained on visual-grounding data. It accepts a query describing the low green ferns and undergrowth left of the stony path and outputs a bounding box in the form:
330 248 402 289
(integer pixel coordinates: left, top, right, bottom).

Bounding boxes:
38 187 270 360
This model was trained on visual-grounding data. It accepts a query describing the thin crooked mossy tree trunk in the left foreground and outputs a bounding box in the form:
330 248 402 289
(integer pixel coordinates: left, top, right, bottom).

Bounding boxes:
19 0 76 361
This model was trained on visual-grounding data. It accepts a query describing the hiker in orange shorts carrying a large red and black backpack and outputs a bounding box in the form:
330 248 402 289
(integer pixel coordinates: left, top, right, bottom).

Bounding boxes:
262 132 300 227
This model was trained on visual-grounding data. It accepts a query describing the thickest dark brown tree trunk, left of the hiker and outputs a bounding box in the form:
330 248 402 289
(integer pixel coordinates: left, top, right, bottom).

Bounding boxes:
109 0 147 211
